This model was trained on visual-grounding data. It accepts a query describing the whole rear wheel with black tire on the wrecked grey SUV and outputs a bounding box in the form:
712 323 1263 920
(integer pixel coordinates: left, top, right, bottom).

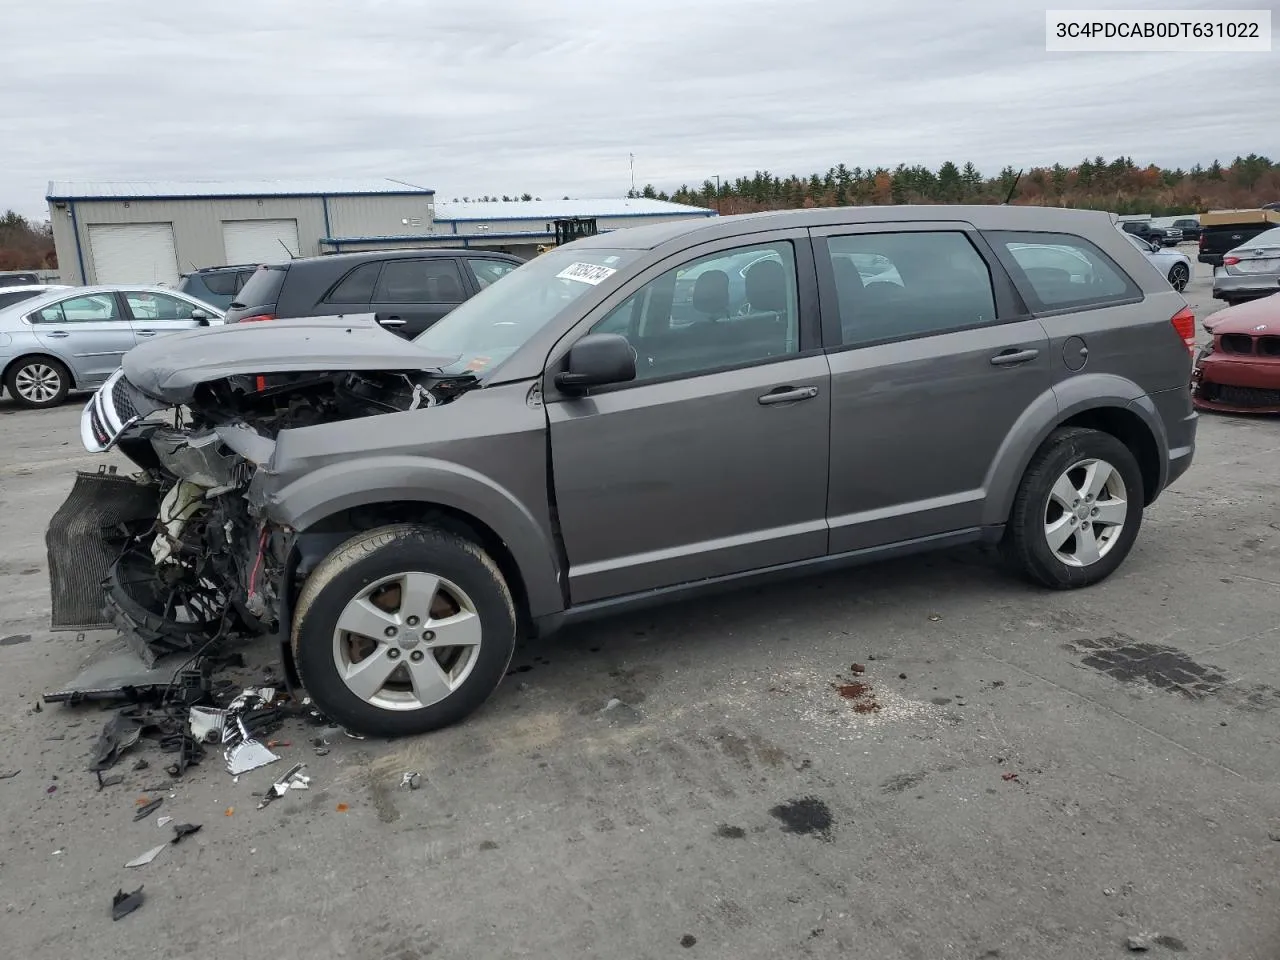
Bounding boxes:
1001 426 1144 590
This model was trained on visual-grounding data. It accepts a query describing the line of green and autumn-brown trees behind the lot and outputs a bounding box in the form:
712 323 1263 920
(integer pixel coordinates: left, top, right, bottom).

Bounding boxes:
628 154 1280 216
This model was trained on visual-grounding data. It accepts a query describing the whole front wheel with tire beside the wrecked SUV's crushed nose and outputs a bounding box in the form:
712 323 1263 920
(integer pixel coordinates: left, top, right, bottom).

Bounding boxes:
292 524 516 736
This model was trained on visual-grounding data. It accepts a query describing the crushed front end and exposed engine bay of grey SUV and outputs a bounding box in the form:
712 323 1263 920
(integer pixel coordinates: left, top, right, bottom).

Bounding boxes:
46 369 479 666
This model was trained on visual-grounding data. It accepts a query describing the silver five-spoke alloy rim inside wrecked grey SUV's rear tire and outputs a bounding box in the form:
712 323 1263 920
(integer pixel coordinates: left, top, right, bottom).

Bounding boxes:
1044 460 1129 567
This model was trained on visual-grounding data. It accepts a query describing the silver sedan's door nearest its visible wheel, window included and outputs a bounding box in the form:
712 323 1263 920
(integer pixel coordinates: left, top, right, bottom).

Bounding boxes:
29 292 134 387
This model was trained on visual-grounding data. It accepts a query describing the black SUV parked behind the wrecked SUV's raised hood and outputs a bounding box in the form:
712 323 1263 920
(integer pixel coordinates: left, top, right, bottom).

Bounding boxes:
227 250 525 337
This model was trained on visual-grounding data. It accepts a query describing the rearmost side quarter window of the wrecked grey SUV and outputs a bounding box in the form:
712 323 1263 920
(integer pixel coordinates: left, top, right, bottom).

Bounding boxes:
986 230 1142 310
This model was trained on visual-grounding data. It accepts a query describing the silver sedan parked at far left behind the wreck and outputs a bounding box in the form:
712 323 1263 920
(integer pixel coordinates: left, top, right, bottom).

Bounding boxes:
0 284 223 407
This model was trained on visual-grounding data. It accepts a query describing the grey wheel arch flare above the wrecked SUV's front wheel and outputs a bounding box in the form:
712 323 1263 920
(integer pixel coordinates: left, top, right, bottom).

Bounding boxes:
260 456 564 617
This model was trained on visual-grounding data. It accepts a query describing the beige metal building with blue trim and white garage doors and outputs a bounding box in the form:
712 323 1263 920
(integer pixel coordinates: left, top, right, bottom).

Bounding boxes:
46 179 716 283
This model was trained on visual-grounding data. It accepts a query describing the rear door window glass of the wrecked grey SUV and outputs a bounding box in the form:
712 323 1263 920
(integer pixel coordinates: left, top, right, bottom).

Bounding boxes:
827 230 996 346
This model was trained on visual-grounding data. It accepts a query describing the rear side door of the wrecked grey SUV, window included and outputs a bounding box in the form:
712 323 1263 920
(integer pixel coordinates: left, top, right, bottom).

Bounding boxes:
812 221 1051 554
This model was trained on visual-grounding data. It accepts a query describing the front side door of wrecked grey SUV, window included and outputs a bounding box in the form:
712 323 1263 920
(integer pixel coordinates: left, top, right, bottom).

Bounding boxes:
547 233 829 604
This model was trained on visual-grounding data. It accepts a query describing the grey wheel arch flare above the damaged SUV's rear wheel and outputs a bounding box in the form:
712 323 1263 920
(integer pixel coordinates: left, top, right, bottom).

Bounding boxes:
982 374 1169 525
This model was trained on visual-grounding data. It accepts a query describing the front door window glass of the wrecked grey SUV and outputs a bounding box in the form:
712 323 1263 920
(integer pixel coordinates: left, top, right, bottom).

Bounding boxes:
591 241 800 380
